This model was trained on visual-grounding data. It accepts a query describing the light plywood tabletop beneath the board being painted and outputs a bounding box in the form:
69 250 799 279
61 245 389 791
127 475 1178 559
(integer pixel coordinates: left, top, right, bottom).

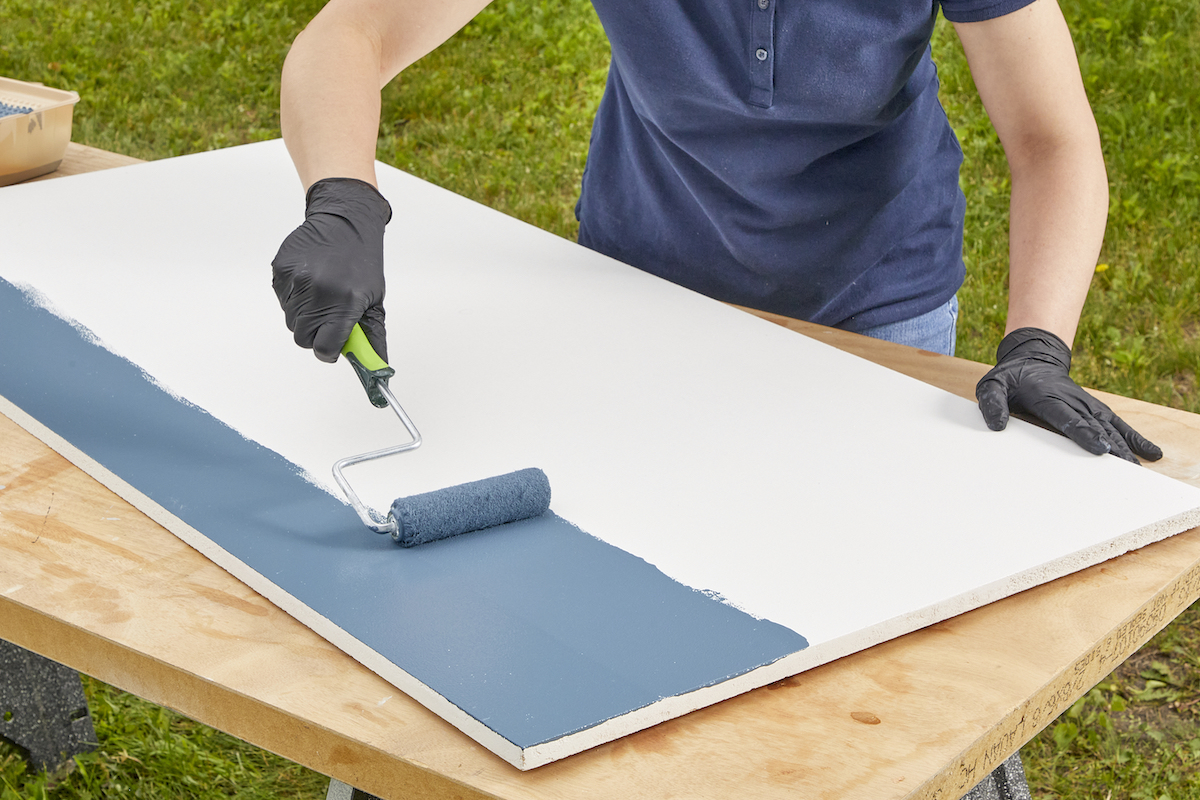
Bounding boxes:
0 149 1200 799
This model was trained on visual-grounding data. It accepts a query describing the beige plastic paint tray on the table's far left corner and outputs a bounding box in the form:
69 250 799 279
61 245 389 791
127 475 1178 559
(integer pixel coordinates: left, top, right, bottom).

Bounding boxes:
0 78 79 186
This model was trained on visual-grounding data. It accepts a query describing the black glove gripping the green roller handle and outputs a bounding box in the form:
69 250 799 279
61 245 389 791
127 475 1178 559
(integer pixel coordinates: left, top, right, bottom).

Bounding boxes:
271 178 391 361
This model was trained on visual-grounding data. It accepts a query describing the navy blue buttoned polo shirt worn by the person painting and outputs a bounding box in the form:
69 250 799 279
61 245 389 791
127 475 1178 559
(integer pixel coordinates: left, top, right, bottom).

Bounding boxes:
576 0 1031 330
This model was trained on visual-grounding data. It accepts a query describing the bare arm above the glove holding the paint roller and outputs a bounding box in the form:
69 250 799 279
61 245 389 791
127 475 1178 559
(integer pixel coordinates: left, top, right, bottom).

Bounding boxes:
280 0 488 190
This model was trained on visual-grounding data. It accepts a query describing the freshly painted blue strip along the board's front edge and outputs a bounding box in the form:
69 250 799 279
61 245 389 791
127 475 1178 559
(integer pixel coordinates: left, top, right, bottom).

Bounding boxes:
0 279 808 747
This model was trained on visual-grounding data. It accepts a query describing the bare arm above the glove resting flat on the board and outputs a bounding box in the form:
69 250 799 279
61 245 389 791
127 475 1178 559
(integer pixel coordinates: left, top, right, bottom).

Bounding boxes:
955 0 1109 345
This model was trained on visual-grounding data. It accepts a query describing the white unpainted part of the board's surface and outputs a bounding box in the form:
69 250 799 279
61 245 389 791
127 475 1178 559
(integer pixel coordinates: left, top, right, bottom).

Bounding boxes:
0 143 1200 652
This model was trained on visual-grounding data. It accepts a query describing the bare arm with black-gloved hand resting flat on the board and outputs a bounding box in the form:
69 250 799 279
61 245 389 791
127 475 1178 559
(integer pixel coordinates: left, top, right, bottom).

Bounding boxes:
955 0 1163 463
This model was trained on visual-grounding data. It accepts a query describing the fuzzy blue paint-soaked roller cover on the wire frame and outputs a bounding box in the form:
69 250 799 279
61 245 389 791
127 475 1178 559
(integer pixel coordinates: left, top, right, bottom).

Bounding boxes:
391 468 550 547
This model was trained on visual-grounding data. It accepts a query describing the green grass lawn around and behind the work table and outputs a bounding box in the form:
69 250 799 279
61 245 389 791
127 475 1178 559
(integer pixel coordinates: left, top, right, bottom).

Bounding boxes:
0 0 1200 800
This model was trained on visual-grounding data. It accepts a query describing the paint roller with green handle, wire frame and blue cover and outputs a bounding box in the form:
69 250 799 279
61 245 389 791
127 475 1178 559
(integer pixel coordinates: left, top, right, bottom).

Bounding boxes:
334 324 550 547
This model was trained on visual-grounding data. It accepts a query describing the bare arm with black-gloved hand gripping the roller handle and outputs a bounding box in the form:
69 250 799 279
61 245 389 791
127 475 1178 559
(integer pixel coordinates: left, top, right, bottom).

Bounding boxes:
271 0 487 362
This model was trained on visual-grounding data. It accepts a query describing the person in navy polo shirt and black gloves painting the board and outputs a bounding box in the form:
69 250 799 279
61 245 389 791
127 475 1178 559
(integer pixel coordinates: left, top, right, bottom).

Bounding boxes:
272 0 1162 462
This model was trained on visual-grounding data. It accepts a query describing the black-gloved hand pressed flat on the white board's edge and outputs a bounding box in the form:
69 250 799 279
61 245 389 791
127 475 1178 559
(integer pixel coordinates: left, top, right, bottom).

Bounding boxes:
976 327 1163 464
